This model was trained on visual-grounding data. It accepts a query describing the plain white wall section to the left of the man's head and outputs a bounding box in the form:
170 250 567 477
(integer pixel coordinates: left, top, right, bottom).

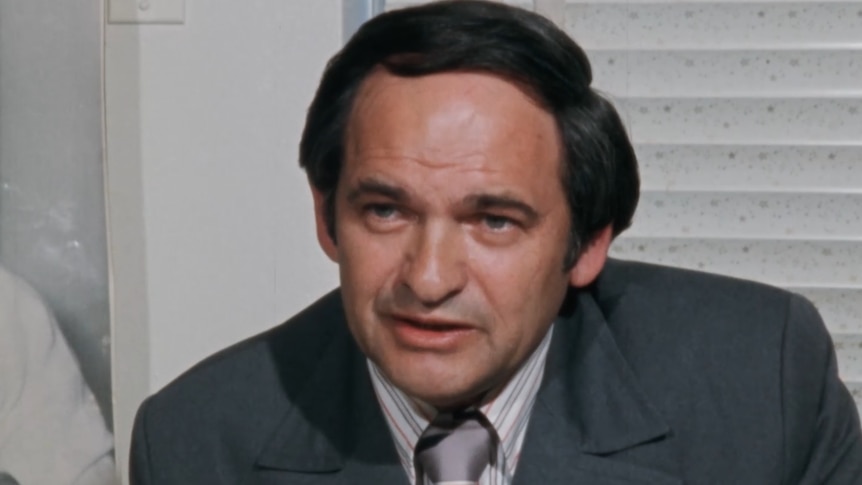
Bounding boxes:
132 0 341 388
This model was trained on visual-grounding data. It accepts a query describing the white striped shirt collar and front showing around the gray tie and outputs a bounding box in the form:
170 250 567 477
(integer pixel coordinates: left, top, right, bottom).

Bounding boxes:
368 326 553 485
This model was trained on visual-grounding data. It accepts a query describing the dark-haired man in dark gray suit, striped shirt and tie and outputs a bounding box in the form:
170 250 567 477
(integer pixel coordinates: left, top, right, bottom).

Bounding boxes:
131 1 862 485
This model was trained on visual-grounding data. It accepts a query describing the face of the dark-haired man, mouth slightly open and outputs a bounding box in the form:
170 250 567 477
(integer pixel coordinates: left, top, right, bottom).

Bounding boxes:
315 71 603 407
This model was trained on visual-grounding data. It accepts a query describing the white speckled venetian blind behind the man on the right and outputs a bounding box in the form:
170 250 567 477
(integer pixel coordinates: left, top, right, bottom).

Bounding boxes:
388 0 862 404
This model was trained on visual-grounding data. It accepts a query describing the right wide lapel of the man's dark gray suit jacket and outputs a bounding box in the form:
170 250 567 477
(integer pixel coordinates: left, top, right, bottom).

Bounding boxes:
514 292 682 485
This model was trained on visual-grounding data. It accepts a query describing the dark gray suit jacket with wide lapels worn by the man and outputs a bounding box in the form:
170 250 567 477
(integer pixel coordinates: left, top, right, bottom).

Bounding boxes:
131 261 862 485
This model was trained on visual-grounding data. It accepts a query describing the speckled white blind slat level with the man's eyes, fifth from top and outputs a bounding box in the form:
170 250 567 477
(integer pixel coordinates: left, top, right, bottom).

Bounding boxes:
628 190 862 239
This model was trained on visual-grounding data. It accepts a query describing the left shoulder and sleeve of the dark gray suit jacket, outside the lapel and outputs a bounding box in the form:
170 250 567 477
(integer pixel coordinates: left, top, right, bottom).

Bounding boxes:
131 290 349 483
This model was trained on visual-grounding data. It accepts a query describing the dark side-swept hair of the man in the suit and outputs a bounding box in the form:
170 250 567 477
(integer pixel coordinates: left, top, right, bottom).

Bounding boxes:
299 0 640 267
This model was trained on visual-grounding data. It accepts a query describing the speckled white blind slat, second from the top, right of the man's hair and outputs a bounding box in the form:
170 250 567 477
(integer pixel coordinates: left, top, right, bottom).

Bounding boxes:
589 48 862 97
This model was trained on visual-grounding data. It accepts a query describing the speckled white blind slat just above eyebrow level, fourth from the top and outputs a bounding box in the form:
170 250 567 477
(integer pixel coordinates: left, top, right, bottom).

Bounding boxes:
635 140 862 192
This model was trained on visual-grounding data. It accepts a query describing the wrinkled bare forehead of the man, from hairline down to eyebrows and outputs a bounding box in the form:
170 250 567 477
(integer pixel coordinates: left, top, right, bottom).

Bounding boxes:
339 72 561 212
